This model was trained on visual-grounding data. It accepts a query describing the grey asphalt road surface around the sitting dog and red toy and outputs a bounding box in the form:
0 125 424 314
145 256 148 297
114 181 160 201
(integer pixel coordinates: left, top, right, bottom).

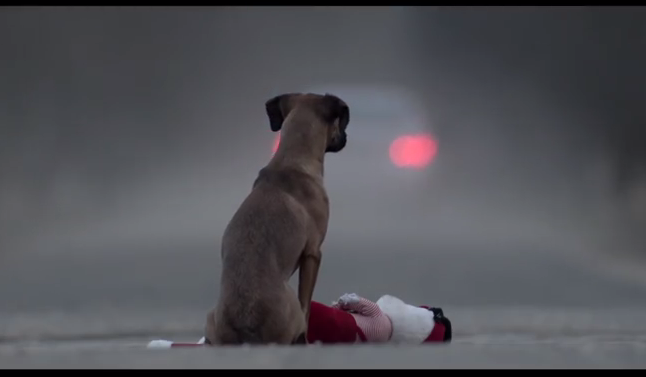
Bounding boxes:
0 223 646 368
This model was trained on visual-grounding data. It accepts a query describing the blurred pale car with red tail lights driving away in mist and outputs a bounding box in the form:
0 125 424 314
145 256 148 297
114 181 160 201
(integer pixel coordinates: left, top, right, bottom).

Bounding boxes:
272 85 439 226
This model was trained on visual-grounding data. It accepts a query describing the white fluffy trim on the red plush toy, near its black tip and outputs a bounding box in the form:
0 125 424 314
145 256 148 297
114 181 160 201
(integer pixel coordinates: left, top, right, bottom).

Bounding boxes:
377 295 435 344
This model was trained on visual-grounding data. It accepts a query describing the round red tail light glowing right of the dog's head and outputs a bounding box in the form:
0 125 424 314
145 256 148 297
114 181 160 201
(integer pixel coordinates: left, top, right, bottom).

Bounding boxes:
389 135 437 169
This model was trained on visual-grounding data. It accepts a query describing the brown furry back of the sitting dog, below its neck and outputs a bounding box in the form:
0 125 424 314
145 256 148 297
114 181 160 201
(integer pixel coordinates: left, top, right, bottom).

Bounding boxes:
215 168 324 344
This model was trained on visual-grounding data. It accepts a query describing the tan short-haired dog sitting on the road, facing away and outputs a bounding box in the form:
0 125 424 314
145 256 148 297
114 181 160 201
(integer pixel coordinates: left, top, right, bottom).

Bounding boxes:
205 93 350 345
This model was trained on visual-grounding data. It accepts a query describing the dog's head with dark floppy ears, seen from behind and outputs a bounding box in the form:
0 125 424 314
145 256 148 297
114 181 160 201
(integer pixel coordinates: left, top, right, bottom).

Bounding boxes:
265 93 350 152
